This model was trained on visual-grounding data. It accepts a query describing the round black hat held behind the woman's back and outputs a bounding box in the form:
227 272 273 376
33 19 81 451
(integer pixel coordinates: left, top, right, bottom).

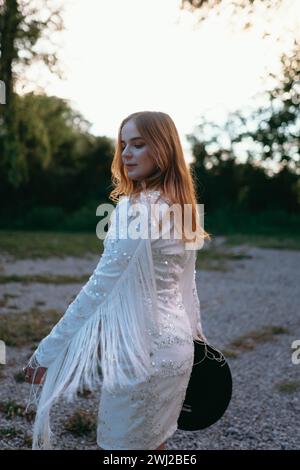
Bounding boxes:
178 340 232 431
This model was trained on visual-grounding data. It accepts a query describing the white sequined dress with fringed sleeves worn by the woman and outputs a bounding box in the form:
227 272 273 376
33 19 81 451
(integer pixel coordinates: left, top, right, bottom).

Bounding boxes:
25 190 203 450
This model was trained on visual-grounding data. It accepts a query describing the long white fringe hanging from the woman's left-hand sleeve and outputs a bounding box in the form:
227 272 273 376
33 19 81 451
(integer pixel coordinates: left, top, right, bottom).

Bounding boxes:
28 238 158 450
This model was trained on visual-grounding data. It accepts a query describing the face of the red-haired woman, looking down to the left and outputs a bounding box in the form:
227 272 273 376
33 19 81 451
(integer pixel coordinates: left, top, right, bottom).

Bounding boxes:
121 119 156 181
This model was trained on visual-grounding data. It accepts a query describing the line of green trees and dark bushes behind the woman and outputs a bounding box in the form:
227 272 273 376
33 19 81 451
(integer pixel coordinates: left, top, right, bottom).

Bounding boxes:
0 0 300 229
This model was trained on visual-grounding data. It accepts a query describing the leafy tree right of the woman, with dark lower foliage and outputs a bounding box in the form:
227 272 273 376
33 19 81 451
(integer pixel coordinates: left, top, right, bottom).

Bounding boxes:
188 40 300 211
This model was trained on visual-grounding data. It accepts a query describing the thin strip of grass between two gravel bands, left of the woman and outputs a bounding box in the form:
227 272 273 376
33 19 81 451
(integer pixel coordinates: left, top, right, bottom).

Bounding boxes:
0 274 89 284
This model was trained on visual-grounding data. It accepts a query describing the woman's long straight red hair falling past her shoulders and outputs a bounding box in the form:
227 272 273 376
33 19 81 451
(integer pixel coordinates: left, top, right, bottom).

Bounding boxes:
109 111 210 241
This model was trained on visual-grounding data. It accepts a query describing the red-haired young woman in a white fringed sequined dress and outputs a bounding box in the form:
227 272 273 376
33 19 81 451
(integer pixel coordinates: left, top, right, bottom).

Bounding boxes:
24 111 210 450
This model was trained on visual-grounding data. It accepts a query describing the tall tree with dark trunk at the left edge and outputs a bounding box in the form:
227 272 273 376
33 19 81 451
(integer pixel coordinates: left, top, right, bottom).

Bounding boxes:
0 0 63 187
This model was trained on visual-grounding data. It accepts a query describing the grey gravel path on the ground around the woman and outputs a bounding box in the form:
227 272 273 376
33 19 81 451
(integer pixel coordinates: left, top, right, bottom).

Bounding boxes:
0 241 300 450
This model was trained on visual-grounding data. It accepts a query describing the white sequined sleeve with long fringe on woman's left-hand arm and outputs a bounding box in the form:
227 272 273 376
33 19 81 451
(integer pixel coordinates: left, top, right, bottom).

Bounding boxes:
28 195 162 449
